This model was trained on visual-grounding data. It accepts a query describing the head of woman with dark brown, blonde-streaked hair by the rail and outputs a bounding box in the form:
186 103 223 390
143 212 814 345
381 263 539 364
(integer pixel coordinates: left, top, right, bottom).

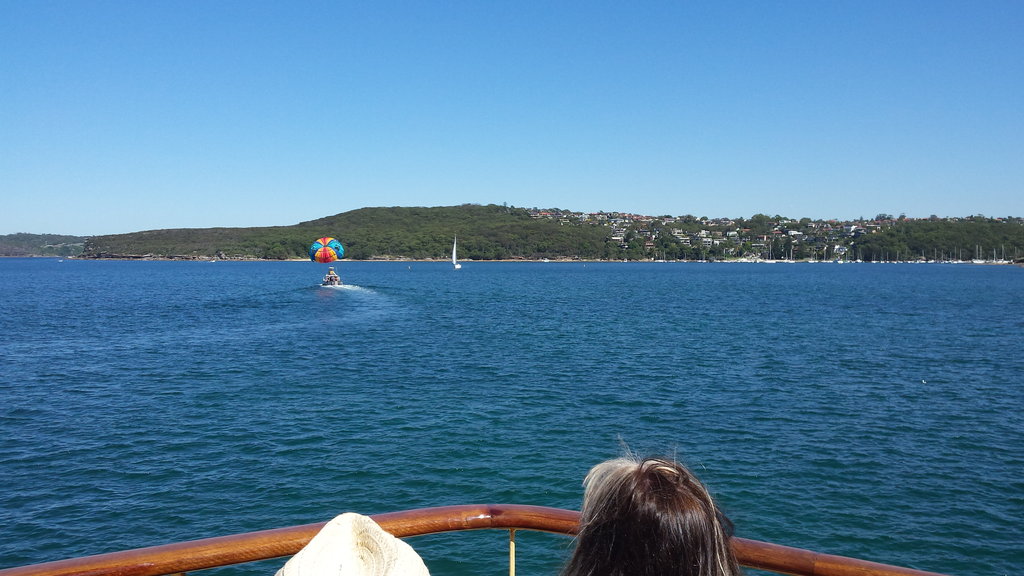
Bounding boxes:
565 457 739 576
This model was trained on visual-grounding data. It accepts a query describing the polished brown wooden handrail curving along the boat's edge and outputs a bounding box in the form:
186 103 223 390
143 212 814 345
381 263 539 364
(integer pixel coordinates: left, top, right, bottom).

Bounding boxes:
0 504 942 576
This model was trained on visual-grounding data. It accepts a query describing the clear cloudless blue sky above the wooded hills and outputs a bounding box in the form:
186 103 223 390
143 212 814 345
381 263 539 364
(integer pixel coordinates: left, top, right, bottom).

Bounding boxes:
0 0 1024 235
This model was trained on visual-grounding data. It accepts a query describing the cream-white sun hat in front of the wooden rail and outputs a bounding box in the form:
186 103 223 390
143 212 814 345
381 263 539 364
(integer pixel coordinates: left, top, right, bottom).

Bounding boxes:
275 512 430 576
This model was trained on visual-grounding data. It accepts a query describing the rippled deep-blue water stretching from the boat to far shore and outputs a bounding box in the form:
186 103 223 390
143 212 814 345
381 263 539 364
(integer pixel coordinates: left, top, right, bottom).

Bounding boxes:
0 259 1024 576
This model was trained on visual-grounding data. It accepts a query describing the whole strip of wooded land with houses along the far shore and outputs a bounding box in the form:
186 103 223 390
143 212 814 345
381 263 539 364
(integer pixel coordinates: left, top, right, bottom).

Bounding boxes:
8 204 1024 261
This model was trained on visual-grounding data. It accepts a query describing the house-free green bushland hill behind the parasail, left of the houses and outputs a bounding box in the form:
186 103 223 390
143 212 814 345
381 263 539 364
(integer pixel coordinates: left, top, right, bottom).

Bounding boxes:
83 204 608 259
